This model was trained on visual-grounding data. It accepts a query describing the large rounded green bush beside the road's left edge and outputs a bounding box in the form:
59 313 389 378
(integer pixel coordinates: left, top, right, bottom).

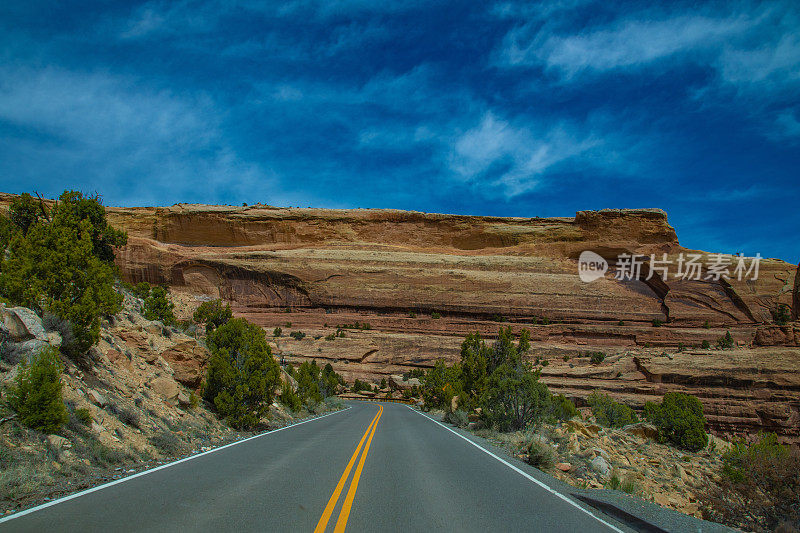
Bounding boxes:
203 318 280 429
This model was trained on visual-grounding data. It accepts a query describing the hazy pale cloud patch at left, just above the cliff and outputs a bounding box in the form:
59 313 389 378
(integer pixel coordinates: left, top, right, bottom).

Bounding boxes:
0 68 274 202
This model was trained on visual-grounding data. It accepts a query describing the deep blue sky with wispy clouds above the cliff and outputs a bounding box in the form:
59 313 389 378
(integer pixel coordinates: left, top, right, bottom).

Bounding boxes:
0 0 800 262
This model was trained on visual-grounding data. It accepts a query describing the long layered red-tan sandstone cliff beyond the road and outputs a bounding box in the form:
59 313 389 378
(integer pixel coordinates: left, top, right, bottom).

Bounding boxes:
0 196 800 443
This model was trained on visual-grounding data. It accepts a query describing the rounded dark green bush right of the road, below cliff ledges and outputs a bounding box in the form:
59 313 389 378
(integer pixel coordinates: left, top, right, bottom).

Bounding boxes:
644 392 708 451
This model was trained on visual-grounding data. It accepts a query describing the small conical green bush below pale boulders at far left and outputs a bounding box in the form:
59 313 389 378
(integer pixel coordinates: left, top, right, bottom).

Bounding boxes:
7 348 69 433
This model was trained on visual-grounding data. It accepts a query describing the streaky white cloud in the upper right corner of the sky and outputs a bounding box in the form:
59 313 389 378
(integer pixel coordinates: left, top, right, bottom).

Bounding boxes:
494 0 800 138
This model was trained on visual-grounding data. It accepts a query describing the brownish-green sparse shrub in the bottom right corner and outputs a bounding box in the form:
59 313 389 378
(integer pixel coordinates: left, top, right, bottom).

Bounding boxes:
709 434 800 531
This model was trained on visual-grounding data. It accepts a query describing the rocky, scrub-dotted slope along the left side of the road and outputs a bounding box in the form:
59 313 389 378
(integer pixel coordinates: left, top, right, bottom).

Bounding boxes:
0 292 332 516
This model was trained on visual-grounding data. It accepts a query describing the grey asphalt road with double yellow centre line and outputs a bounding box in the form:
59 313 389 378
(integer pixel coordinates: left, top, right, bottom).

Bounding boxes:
0 402 626 533
